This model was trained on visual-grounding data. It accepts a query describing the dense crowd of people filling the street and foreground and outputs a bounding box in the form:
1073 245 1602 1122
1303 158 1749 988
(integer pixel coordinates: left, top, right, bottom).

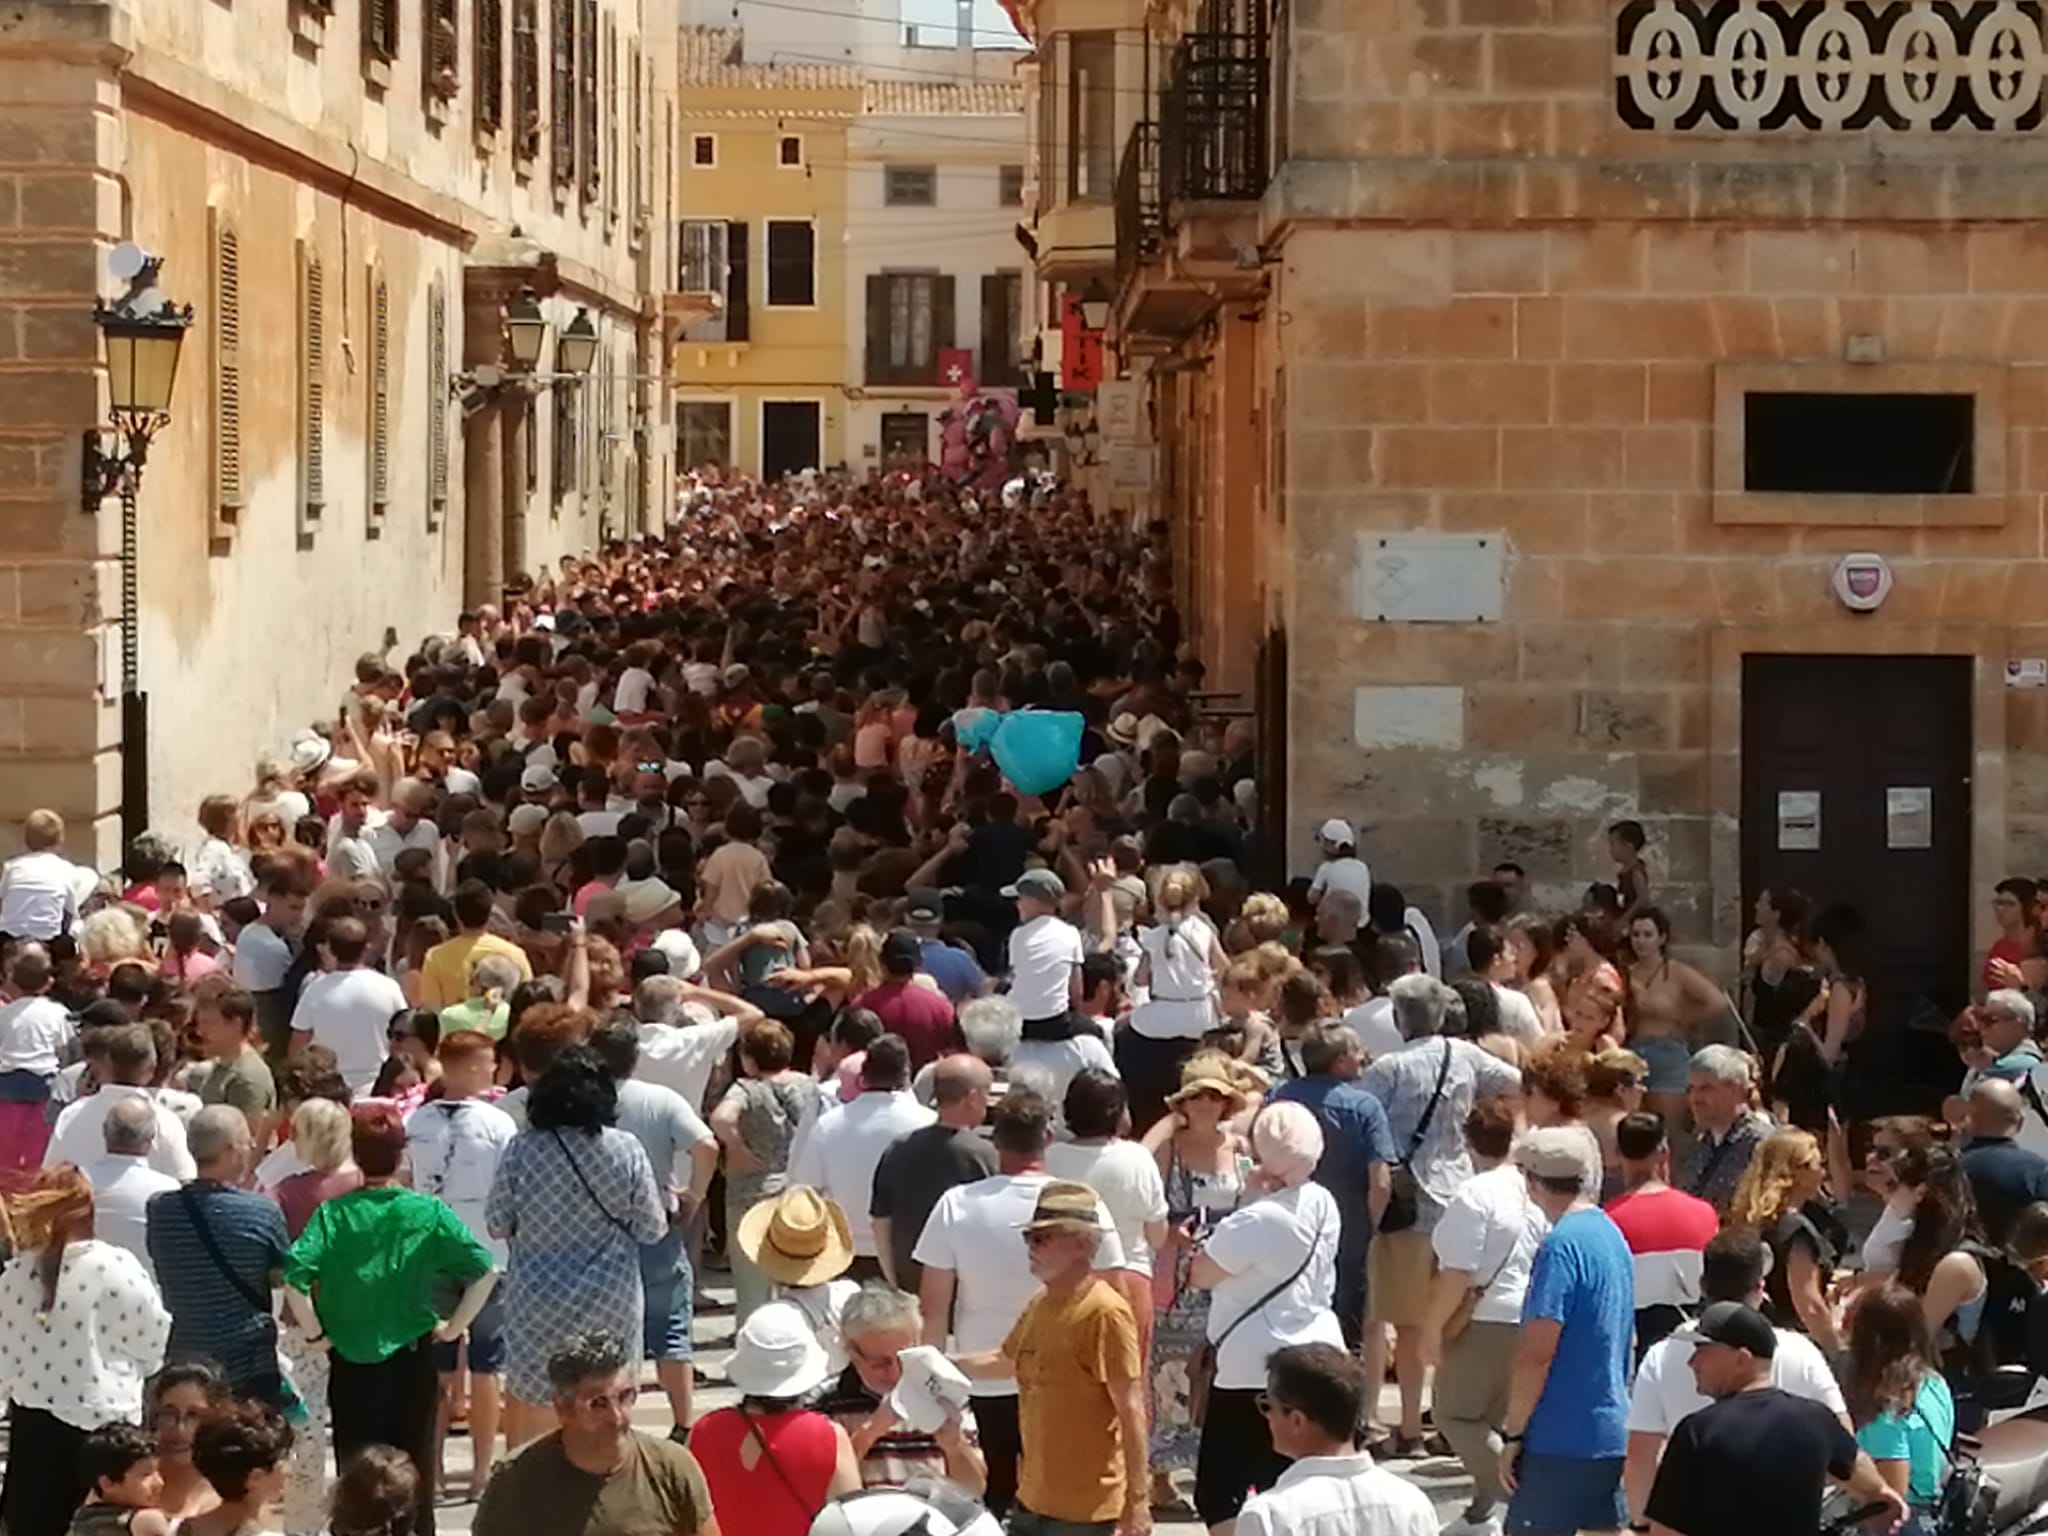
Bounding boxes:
0 462 2048 1536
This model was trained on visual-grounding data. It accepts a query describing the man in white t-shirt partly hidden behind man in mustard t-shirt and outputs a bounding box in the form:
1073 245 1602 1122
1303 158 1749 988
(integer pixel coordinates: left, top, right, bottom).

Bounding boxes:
913 1090 1124 1518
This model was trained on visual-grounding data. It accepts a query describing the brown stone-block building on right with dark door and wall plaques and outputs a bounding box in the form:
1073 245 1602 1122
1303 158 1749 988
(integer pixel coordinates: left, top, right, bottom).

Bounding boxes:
1112 0 2048 1024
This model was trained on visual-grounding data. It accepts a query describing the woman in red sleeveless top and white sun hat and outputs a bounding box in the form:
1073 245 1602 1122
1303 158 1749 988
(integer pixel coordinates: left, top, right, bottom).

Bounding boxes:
690 1300 860 1536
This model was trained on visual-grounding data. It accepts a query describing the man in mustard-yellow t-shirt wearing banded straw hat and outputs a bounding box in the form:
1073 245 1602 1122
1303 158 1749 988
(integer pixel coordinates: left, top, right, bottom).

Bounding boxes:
956 1180 1151 1536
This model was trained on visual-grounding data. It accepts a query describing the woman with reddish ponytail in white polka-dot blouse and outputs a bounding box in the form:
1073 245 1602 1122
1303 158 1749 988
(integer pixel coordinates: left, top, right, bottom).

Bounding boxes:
0 1163 170 1536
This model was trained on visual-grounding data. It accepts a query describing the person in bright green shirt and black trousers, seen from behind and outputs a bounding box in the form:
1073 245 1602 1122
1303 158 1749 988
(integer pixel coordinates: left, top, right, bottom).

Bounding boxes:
285 1104 498 1536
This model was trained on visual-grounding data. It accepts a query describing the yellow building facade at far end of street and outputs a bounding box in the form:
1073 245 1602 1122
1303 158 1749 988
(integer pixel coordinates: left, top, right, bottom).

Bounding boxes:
674 27 862 475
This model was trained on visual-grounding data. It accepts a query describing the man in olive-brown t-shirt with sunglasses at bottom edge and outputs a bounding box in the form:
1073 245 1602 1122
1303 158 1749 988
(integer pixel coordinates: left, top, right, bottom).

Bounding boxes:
473 1333 719 1536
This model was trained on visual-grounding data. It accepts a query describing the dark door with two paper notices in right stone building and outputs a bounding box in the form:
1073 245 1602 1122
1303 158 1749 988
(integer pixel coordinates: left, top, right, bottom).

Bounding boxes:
1743 655 1972 1114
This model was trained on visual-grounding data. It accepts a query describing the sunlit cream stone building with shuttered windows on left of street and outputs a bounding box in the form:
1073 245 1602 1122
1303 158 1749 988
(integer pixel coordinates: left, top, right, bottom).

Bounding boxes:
0 0 674 862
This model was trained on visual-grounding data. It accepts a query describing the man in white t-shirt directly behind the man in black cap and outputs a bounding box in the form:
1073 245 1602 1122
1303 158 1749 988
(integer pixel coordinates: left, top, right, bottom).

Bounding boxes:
1622 1227 1851 1522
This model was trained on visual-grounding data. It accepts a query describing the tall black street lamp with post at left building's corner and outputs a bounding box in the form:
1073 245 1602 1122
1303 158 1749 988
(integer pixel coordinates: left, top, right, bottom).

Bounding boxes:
80 244 193 860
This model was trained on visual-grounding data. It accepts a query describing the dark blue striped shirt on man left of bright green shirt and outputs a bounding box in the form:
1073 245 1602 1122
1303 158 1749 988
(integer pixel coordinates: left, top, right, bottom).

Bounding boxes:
147 1180 291 1393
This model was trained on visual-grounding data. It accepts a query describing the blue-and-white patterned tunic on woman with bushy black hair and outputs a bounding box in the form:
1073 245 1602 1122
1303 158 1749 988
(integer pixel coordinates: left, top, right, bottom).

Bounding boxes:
483 1126 668 1403
